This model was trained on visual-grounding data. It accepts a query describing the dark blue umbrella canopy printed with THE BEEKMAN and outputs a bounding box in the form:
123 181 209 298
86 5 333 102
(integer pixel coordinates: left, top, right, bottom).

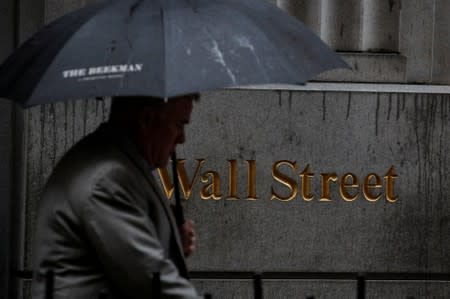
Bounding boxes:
0 0 347 107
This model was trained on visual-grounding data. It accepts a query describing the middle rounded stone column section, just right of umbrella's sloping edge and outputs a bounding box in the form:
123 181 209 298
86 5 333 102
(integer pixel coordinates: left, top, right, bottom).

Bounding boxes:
321 0 361 51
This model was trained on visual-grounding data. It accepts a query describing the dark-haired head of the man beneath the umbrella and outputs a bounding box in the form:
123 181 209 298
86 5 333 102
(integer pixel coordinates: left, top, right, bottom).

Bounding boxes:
110 95 198 167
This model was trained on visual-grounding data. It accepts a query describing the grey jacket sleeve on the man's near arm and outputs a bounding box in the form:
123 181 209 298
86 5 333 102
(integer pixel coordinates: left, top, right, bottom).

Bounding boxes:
82 166 200 299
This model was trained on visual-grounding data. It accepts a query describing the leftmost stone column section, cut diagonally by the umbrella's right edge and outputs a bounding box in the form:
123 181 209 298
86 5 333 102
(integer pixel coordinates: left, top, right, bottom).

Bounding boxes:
277 0 322 36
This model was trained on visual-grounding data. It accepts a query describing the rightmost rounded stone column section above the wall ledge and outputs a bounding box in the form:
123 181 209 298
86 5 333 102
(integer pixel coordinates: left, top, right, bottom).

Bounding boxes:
362 0 400 52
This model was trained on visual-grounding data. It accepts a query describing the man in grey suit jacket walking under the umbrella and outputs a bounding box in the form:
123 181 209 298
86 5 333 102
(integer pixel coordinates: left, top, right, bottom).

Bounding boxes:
32 95 199 299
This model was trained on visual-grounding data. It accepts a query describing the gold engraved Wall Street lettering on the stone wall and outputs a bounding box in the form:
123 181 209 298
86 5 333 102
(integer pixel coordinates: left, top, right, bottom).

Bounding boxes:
158 159 399 203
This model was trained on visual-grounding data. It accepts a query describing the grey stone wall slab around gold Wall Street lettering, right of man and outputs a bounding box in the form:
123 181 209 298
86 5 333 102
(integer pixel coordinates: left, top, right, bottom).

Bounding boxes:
173 90 450 298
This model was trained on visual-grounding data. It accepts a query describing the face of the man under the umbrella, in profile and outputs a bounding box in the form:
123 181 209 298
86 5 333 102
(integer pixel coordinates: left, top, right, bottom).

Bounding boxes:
140 96 192 167
